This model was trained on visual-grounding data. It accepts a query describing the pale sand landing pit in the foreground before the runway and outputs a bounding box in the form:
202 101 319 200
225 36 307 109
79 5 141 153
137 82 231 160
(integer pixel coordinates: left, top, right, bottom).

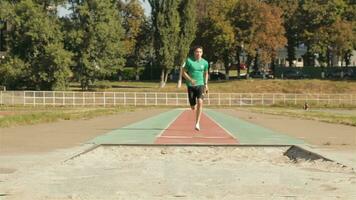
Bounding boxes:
0 146 356 200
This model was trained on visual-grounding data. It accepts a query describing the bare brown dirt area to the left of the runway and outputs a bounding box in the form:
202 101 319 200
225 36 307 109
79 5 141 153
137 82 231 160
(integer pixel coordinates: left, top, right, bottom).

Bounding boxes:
0 109 167 155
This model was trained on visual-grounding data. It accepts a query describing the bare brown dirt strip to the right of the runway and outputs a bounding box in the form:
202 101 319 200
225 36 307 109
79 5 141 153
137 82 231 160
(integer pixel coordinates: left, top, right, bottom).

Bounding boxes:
220 109 356 169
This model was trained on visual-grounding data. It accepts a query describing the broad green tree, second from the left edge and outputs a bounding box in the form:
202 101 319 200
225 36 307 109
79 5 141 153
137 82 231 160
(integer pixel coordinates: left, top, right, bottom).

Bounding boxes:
66 0 125 90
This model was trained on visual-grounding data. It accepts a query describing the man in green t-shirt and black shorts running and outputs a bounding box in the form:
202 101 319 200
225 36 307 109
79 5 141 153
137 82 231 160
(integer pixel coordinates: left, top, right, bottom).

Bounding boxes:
183 46 209 131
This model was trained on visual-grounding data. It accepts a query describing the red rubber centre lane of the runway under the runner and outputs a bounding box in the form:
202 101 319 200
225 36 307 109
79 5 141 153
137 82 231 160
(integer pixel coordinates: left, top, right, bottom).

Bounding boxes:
155 110 238 144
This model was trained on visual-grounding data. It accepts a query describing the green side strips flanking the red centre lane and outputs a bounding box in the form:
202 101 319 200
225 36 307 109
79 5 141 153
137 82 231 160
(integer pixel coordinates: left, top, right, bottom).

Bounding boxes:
89 109 304 145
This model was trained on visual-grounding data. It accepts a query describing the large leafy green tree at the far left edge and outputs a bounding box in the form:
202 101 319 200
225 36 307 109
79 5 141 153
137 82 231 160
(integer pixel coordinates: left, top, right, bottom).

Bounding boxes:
1 0 72 90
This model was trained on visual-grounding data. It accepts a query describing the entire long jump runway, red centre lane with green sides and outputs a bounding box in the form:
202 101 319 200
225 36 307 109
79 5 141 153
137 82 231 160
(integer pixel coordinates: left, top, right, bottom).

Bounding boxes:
90 109 304 145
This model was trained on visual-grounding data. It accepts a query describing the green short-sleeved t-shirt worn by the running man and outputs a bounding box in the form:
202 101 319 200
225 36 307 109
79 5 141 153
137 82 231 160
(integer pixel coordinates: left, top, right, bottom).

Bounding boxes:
184 58 209 86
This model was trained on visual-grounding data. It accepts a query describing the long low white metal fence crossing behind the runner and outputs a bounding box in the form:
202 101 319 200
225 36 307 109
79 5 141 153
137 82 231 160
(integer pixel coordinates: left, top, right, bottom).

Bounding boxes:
0 91 356 107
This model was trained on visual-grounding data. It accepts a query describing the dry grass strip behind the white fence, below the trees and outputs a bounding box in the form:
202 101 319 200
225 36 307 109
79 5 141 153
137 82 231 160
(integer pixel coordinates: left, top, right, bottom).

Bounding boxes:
70 79 356 94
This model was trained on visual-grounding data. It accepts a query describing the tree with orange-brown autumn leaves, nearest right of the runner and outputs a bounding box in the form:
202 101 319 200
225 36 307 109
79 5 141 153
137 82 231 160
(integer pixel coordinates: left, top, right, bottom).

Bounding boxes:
231 0 287 76
